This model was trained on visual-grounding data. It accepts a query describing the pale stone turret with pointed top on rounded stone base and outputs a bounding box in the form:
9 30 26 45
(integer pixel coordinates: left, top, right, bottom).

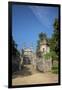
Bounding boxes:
37 39 52 72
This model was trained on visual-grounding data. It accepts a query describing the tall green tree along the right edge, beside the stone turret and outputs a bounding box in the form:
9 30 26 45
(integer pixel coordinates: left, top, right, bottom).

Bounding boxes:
50 19 60 59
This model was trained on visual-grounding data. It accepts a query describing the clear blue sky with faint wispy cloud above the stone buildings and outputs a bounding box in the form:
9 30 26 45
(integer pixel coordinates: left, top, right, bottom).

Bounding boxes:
12 5 59 51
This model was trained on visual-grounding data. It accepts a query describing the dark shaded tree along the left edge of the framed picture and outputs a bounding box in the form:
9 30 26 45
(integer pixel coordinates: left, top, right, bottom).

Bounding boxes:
11 38 20 73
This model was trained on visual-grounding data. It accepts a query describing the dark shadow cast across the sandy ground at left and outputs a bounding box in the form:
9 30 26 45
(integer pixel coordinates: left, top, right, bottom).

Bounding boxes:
12 66 32 79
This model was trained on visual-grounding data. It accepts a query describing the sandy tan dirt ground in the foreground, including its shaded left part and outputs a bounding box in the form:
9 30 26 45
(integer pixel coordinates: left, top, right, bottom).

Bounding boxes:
12 65 58 85
